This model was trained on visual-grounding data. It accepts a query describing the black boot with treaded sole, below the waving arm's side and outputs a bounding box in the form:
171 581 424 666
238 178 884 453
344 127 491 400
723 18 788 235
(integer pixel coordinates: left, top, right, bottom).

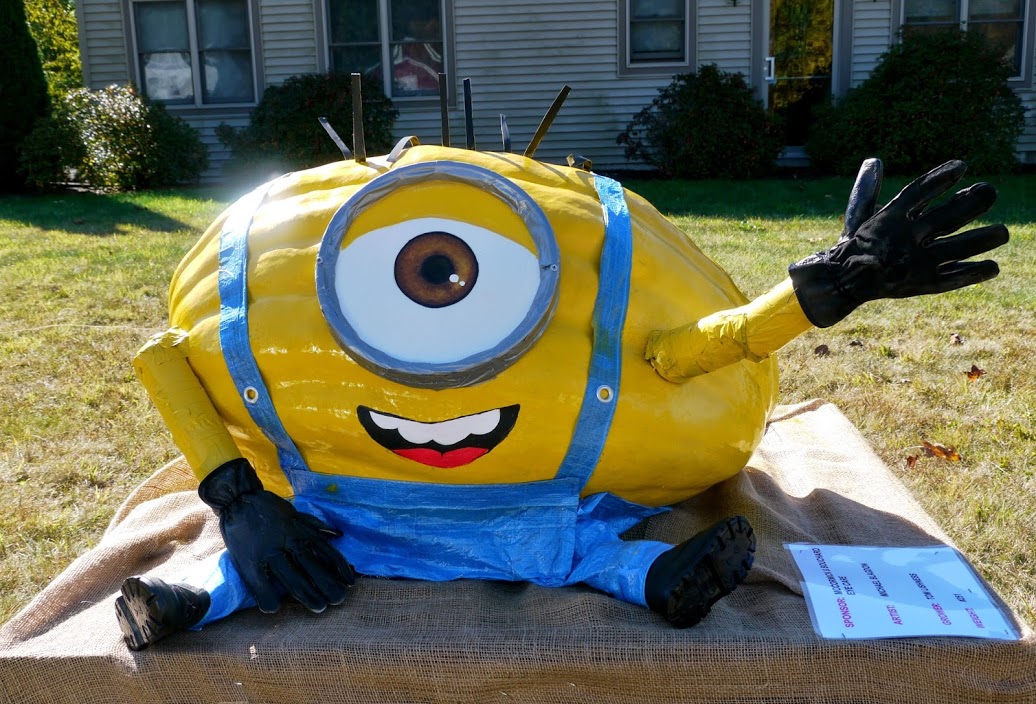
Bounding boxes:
644 516 755 628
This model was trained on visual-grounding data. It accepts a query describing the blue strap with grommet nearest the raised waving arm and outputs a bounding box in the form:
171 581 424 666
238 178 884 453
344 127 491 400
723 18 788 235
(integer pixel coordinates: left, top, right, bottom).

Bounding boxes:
557 174 633 489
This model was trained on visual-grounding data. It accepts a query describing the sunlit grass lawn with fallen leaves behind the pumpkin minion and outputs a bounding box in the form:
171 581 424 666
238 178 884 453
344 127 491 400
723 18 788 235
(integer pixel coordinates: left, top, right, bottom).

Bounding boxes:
0 171 1036 623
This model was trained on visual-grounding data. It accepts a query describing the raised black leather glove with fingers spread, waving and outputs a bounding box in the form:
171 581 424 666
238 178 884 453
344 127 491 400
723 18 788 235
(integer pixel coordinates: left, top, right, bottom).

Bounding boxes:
788 159 1008 327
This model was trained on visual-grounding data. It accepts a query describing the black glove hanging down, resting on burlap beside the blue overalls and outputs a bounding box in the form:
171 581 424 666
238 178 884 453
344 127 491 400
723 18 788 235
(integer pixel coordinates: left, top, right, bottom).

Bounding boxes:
198 460 355 614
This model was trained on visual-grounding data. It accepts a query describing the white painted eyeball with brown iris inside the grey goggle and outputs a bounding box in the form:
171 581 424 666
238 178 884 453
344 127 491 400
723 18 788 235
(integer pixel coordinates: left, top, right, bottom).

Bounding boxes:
335 217 540 363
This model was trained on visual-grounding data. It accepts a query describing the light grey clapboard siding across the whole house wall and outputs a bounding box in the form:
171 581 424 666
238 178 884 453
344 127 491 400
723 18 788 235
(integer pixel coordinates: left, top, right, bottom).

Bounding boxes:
76 0 1036 181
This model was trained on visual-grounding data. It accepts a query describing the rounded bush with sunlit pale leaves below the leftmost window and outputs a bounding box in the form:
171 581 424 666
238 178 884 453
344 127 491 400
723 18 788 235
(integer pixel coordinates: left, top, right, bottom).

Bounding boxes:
21 85 208 190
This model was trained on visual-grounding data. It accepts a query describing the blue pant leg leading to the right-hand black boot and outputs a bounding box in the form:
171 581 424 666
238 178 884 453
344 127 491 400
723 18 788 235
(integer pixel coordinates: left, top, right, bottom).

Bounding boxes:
568 511 672 607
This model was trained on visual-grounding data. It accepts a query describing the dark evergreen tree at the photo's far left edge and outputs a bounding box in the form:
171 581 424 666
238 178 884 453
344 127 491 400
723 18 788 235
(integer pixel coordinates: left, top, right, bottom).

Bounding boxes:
0 0 49 190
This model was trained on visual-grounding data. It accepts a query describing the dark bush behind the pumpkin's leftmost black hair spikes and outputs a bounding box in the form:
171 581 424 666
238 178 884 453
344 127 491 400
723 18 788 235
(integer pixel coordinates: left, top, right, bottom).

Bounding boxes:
217 72 399 173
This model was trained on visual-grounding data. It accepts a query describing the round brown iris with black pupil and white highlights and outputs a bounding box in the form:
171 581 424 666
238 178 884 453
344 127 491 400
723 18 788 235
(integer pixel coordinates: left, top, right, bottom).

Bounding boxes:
396 232 479 307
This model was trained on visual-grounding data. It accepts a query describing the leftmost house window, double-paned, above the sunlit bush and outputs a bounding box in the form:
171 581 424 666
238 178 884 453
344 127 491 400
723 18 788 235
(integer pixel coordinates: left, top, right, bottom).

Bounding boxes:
132 0 256 106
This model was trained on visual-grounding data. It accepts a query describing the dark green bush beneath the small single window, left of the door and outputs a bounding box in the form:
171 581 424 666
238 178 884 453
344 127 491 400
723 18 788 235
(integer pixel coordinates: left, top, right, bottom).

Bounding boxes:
616 64 783 178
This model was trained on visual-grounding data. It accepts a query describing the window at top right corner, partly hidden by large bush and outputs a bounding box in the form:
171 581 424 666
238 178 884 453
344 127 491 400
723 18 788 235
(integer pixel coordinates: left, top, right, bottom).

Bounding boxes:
902 0 1032 79
